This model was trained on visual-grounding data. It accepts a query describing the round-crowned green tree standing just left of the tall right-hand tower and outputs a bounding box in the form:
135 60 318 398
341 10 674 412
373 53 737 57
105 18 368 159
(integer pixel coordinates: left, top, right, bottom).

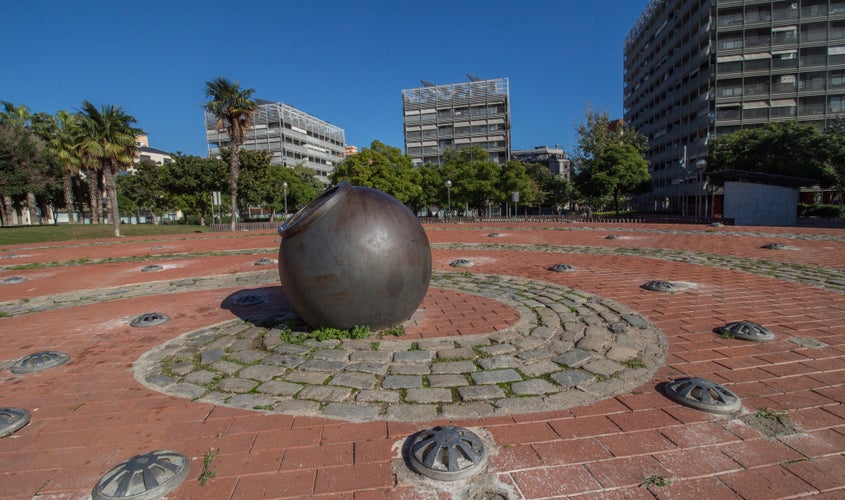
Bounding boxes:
576 144 651 215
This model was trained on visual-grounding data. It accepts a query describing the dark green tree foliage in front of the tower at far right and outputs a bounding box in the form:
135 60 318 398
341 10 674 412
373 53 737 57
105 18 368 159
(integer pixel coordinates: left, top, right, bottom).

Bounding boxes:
707 122 836 186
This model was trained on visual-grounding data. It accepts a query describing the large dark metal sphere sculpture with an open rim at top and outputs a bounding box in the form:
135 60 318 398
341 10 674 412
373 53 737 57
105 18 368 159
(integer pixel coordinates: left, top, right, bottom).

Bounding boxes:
279 182 431 329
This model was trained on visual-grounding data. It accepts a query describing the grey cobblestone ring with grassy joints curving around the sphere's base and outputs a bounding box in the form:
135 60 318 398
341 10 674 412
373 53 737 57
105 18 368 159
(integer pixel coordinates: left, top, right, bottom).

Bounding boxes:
135 272 667 421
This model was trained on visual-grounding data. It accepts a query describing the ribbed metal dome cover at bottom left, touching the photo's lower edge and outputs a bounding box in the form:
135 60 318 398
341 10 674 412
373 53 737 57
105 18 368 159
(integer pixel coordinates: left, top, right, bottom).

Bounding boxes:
91 451 190 500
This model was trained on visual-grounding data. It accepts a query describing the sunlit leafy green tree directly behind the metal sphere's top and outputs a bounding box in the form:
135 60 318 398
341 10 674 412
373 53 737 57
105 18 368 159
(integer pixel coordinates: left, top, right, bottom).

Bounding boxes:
331 140 422 204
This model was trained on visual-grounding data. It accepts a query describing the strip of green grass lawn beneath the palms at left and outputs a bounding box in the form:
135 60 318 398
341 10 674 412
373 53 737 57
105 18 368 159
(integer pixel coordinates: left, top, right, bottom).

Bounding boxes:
0 224 208 246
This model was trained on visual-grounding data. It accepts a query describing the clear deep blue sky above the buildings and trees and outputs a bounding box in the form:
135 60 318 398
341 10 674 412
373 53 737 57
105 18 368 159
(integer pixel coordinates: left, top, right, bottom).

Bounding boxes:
0 0 648 156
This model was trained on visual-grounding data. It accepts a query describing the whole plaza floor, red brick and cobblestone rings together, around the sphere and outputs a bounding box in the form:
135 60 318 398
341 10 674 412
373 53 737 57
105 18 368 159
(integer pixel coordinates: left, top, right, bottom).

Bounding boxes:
0 221 845 499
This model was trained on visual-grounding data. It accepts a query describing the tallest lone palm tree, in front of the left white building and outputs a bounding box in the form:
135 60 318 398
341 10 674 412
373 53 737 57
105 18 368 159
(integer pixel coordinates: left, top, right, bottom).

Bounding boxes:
202 77 258 231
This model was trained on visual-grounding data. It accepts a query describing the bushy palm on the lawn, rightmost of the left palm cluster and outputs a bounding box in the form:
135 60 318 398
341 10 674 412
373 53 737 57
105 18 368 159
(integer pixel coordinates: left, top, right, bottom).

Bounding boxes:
80 101 144 237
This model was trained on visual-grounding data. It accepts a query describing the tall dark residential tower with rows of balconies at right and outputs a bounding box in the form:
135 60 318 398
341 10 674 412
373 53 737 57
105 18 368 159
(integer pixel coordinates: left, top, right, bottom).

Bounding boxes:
624 0 845 215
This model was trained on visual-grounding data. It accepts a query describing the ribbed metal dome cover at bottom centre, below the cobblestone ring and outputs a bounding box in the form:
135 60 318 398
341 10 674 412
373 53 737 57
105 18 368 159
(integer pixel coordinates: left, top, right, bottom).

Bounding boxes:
409 425 487 481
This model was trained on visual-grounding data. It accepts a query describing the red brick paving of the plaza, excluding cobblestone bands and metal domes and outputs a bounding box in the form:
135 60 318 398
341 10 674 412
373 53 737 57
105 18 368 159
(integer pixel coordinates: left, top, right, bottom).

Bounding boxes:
0 224 845 499
